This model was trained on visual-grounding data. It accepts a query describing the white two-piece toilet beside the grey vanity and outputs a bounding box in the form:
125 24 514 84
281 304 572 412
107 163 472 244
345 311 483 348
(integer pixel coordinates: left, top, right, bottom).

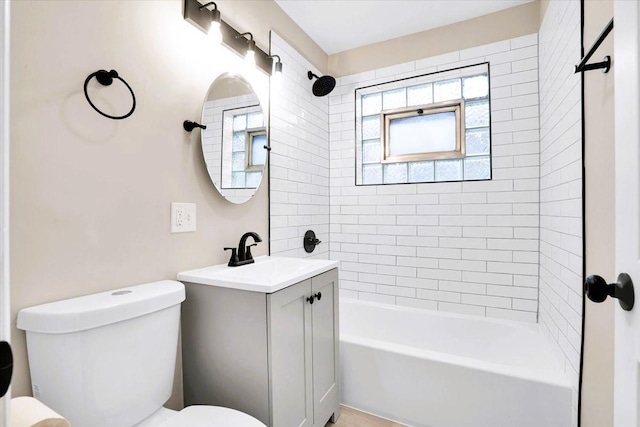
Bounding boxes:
18 280 265 427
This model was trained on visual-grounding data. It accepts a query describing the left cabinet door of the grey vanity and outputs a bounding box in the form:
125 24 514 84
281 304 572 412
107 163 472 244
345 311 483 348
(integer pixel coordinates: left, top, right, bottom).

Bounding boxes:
268 280 313 427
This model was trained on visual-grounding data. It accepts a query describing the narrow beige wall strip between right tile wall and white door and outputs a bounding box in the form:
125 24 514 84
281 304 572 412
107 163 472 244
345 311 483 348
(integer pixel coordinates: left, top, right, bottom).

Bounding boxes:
582 0 617 427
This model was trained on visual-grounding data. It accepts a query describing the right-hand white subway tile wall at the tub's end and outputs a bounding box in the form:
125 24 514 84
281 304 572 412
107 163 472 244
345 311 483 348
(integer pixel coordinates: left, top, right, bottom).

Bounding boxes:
539 0 583 426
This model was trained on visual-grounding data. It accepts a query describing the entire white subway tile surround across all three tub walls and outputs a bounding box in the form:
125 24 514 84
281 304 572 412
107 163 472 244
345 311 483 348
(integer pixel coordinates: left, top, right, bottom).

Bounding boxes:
270 25 582 426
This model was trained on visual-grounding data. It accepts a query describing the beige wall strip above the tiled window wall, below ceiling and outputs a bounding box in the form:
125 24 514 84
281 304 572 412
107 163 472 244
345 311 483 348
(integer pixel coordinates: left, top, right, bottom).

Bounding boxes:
329 1 540 77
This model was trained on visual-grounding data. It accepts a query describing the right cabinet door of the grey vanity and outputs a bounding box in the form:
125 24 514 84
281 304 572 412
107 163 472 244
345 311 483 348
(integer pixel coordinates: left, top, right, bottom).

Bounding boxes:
311 269 339 427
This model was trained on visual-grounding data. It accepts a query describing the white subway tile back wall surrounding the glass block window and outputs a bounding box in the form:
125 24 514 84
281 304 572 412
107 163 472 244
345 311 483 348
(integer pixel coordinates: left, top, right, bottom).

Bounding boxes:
329 34 539 322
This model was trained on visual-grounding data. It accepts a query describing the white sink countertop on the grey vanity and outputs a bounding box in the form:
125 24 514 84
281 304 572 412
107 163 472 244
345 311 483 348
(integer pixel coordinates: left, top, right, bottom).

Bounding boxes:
178 256 338 293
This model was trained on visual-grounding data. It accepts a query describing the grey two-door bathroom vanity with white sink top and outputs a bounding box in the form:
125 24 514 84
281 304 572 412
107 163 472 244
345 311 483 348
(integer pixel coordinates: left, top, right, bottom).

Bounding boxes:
178 256 340 427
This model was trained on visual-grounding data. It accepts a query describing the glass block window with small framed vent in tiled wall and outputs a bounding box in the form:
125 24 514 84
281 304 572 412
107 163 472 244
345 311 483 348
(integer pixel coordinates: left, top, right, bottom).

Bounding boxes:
356 63 491 185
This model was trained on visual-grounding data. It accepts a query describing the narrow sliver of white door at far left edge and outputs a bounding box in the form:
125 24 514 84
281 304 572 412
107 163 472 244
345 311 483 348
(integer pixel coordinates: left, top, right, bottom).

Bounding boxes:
0 1 12 427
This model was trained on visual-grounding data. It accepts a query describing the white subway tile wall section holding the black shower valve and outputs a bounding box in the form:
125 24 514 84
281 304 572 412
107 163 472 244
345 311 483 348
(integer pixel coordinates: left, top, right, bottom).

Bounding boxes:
269 32 329 259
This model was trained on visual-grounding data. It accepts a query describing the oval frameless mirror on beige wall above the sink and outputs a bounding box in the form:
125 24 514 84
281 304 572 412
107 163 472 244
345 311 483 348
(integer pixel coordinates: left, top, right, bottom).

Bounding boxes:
201 73 267 203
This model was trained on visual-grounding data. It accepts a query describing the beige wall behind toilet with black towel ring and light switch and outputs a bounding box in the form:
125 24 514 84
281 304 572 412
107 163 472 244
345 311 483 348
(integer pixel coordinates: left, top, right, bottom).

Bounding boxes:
10 0 290 407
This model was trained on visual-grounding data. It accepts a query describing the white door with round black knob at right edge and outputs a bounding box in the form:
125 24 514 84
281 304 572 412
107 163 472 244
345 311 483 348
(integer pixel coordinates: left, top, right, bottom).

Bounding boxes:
613 0 640 427
